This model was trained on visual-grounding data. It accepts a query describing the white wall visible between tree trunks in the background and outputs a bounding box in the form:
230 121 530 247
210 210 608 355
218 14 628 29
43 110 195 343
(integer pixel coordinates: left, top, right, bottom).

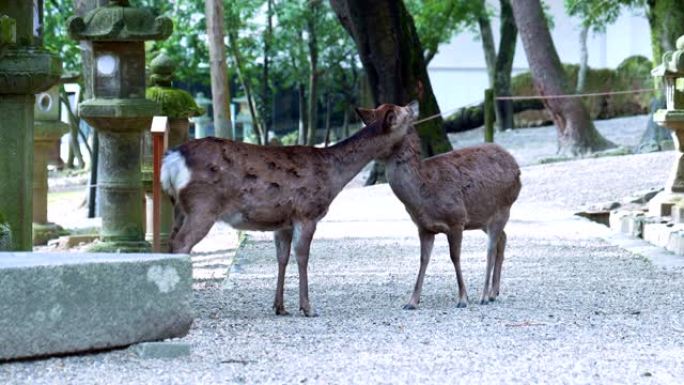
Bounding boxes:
428 0 651 112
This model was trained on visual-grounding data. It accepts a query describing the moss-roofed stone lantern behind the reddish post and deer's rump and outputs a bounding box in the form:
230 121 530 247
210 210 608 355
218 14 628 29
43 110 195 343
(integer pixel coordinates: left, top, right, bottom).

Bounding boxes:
143 53 204 250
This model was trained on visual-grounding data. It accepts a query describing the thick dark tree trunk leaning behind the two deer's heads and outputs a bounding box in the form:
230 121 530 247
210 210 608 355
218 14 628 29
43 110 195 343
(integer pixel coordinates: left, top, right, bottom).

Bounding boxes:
330 0 451 156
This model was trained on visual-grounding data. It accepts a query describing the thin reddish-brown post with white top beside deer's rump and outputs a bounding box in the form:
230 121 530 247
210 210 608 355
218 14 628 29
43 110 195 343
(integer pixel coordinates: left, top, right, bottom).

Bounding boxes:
151 116 169 253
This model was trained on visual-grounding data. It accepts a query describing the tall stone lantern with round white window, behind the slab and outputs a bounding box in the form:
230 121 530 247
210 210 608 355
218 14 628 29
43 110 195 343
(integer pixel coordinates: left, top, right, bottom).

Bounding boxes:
67 0 173 252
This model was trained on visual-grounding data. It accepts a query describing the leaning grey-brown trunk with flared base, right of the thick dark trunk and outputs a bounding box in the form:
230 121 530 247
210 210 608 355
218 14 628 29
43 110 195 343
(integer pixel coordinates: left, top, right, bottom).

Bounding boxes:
511 0 615 156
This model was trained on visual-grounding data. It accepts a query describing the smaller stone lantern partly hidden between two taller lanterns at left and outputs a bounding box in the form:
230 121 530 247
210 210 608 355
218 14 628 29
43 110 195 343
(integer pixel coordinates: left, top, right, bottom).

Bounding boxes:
33 84 69 245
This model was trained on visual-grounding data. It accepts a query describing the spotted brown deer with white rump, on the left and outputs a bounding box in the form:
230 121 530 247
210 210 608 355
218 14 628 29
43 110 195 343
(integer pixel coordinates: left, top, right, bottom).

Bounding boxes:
160 101 415 317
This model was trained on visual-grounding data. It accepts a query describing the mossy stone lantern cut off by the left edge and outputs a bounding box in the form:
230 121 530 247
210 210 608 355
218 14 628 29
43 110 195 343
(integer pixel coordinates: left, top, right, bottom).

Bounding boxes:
0 1 62 251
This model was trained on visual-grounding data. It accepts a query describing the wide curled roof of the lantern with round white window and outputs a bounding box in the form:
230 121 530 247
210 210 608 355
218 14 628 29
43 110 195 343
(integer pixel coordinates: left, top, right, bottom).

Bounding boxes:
67 0 173 41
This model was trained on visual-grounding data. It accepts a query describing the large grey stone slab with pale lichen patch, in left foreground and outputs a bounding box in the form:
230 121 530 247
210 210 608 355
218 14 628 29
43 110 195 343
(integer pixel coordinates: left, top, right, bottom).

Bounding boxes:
0 253 193 361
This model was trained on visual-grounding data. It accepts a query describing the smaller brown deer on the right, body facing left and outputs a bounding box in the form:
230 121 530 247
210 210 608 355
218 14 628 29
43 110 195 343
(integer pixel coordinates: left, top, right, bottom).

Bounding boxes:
357 106 521 310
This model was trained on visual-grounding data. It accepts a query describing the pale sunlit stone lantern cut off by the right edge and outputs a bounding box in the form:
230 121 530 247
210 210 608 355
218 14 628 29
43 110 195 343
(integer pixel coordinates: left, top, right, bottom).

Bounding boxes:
649 36 684 216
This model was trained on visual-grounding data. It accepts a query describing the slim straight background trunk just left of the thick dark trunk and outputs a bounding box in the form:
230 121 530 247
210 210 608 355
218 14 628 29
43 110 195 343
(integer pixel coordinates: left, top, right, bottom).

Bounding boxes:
306 0 321 146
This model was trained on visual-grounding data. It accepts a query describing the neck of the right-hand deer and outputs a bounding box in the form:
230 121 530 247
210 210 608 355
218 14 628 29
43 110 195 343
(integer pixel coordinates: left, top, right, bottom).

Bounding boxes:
386 127 423 205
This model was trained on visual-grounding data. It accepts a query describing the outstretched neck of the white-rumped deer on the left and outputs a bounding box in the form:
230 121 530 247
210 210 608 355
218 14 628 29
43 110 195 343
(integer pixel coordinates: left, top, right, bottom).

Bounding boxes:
326 123 396 190
